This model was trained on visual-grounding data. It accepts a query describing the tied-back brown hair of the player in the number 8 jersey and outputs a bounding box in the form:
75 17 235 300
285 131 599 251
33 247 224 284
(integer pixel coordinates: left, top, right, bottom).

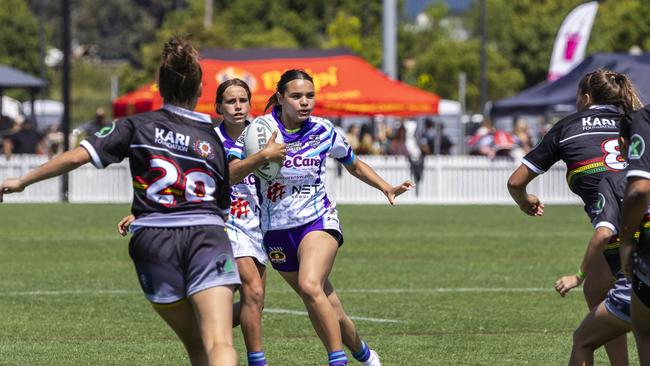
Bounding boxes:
578 69 643 113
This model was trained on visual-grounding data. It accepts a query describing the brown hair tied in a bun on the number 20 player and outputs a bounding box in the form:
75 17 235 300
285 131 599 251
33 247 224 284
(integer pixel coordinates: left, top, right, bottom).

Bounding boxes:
158 36 203 105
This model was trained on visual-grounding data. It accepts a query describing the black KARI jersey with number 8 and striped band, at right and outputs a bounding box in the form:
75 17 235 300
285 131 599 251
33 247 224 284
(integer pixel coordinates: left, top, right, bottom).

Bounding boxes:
522 105 627 219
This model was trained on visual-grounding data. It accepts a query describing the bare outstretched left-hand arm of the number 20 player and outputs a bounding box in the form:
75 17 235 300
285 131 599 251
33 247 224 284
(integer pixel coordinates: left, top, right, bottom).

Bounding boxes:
0 147 90 202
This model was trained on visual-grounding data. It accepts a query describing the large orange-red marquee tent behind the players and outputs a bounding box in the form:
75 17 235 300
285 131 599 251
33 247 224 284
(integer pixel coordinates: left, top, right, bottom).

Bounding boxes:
113 49 440 118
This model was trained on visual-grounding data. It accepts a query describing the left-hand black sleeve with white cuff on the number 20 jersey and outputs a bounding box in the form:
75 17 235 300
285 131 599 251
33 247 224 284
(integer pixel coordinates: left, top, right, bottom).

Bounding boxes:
80 119 134 169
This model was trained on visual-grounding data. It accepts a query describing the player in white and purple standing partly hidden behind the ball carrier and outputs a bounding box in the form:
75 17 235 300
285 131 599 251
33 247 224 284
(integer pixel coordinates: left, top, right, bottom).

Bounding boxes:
215 79 285 366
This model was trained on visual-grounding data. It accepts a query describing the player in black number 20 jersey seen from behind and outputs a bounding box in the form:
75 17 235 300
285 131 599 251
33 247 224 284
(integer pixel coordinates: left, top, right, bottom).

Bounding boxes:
0 37 240 366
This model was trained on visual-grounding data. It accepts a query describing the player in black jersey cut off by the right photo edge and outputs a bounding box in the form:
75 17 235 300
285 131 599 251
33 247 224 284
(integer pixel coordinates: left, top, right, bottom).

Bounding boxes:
620 105 650 366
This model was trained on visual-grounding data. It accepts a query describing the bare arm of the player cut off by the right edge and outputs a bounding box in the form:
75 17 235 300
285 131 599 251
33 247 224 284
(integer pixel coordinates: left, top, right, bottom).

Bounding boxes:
620 177 650 280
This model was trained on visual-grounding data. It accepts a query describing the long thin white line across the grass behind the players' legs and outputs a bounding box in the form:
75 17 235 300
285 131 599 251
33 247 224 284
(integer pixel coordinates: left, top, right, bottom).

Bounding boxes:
0 287 553 296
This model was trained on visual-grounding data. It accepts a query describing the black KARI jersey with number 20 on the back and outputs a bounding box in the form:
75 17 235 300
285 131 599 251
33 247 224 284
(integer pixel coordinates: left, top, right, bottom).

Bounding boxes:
81 105 230 227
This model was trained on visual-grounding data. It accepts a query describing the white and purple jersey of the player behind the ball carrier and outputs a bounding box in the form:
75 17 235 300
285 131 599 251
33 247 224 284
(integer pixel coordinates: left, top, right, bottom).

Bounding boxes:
215 123 266 264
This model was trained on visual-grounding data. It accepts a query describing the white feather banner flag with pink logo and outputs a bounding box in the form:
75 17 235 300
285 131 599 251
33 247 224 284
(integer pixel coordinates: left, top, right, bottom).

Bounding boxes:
548 1 598 81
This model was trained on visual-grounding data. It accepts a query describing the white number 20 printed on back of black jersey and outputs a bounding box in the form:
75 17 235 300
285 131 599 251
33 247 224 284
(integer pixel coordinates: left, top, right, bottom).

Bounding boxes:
146 156 217 206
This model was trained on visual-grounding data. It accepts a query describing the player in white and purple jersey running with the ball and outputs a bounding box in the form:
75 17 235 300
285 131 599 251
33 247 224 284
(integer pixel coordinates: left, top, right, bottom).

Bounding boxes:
229 70 414 366
